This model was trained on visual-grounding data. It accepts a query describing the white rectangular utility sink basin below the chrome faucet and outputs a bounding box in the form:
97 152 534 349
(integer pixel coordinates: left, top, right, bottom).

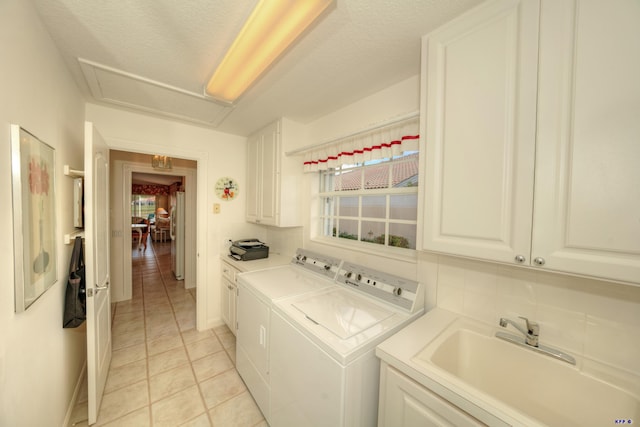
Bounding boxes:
413 321 640 426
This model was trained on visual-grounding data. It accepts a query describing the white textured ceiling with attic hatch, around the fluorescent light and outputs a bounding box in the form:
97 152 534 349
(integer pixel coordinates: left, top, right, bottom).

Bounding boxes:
33 0 481 135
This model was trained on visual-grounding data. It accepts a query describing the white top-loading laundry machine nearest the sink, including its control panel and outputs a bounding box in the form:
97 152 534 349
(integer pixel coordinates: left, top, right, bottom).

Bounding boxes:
269 263 424 427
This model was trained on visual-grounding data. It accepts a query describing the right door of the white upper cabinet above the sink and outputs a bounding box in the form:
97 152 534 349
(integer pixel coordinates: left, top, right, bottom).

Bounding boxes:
531 0 640 284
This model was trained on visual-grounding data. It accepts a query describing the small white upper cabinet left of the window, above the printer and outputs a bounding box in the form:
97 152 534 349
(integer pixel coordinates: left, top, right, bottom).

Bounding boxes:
247 118 302 227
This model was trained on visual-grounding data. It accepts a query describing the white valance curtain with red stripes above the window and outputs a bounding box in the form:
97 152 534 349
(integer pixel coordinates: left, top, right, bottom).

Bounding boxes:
304 117 420 172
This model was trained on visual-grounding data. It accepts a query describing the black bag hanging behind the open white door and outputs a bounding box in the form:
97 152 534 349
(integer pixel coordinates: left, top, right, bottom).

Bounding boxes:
62 236 87 328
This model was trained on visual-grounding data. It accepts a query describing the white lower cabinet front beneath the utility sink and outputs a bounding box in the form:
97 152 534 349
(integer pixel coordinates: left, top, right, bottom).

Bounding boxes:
378 362 485 427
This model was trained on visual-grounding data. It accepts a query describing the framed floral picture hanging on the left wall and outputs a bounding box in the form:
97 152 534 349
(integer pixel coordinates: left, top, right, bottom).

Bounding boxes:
11 124 58 313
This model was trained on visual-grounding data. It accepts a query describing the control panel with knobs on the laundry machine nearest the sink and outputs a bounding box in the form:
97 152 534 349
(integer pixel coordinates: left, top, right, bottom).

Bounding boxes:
336 262 424 312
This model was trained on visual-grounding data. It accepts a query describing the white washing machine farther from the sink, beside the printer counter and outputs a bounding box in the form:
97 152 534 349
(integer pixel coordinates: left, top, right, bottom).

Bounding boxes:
236 249 341 422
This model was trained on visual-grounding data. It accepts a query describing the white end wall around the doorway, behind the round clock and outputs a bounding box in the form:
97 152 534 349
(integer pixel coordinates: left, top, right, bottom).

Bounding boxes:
86 104 266 329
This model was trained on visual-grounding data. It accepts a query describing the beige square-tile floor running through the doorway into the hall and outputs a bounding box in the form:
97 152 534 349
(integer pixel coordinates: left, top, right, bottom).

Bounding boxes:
72 241 267 427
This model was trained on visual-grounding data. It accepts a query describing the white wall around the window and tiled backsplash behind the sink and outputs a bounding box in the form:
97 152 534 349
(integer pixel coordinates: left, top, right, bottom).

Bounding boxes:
288 77 640 394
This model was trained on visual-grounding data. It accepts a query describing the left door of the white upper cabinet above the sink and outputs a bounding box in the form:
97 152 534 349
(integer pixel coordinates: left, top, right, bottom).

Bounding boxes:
420 0 539 262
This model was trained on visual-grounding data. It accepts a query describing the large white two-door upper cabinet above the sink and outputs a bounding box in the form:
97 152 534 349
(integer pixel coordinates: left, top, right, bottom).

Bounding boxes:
421 0 640 284
